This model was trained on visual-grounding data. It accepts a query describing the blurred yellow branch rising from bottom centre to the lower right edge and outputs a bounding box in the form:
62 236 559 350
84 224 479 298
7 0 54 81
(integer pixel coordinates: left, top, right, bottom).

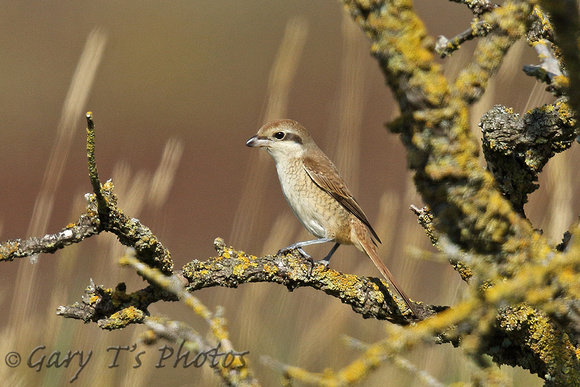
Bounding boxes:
286 229 580 386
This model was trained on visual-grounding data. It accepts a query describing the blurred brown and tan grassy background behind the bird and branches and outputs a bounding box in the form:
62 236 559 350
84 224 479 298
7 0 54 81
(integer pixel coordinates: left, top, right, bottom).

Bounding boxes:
0 0 580 385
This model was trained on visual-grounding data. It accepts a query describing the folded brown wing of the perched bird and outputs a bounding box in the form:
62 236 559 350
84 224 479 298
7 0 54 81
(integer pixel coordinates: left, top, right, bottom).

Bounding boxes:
304 155 381 243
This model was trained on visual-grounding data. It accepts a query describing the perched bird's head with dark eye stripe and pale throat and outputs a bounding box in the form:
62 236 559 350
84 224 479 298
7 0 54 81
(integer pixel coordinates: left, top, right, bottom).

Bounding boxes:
246 119 317 162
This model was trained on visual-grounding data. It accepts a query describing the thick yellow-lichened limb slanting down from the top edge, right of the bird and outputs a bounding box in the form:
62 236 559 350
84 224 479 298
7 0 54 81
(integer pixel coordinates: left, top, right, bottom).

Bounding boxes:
345 1 549 275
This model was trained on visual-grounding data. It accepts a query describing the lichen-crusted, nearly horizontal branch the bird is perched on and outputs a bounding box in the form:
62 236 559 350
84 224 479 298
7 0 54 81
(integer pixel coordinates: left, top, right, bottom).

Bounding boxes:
57 242 447 328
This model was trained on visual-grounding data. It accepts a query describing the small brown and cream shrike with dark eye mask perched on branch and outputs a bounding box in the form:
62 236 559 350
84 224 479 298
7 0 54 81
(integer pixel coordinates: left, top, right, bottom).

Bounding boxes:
246 119 417 315
